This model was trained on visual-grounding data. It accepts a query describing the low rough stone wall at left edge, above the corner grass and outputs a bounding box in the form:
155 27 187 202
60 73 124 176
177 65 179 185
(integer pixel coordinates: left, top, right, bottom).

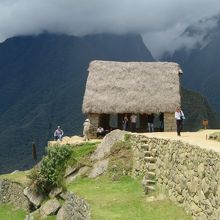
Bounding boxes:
0 180 31 211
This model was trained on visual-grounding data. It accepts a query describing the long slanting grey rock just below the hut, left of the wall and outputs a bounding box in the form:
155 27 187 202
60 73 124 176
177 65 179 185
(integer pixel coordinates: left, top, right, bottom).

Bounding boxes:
91 129 126 160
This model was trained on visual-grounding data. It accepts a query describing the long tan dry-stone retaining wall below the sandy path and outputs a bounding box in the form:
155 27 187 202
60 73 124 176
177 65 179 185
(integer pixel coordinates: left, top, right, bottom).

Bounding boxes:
131 135 220 220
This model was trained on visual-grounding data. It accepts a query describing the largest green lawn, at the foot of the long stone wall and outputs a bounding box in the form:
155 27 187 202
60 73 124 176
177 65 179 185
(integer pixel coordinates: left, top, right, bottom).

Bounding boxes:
68 177 192 220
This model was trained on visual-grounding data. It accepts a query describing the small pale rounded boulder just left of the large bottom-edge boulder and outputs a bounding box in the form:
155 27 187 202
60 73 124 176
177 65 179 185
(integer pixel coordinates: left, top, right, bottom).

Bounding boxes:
40 198 61 216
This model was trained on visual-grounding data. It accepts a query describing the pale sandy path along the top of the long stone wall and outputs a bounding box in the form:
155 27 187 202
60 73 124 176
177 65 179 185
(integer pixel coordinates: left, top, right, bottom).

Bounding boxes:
142 130 220 153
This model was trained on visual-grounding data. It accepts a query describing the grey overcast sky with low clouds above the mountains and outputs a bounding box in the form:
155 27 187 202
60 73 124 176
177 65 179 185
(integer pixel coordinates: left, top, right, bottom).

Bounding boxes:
0 0 220 57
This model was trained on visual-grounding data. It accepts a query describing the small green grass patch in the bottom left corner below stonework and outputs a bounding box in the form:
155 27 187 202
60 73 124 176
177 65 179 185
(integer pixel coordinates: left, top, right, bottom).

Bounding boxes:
0 204 26 220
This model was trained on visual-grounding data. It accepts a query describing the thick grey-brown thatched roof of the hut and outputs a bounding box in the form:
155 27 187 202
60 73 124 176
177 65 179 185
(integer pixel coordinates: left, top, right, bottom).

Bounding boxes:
83 61 182 114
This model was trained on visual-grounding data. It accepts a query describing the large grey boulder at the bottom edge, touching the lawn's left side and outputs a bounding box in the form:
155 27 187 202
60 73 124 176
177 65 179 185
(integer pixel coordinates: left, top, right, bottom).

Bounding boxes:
56 193 90 220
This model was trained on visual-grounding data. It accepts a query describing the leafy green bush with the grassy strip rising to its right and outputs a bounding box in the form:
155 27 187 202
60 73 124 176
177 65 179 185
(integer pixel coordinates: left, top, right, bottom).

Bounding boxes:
28 143 96 194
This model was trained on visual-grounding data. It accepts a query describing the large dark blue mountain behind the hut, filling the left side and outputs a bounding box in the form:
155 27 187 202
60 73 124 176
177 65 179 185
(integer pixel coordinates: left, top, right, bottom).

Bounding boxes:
0 34 154 173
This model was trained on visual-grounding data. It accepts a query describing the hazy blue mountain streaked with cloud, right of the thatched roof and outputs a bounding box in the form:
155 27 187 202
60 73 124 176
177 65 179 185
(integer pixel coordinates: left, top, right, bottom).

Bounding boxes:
162 15 220 115
